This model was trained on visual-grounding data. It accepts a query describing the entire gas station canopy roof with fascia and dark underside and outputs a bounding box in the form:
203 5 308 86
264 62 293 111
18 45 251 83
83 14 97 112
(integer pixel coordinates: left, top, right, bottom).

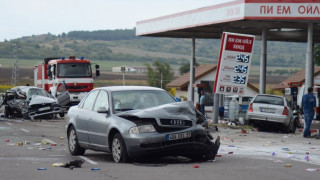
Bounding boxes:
136 0 320 43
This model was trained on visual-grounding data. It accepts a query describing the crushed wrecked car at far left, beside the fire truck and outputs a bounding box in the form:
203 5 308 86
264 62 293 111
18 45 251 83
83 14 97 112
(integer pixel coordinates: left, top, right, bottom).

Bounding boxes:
0 86 64 119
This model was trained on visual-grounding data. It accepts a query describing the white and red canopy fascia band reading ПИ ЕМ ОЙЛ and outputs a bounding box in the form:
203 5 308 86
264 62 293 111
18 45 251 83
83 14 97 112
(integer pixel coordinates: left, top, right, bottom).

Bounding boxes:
136 0 320 36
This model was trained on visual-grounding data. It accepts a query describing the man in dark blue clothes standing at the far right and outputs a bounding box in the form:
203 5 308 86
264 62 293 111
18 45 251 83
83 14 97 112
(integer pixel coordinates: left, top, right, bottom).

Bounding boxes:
302 87 316 138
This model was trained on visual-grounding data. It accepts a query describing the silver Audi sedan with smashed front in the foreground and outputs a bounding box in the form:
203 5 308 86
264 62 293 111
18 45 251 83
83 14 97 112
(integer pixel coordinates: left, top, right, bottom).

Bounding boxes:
66 86 220 162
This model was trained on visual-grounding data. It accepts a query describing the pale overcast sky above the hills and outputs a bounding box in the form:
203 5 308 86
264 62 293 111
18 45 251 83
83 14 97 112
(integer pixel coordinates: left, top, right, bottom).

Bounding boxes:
0 0 233 42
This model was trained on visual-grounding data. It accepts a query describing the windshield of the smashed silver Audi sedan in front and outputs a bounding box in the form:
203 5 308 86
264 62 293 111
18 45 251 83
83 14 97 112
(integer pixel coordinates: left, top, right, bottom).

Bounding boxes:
112 90 176 112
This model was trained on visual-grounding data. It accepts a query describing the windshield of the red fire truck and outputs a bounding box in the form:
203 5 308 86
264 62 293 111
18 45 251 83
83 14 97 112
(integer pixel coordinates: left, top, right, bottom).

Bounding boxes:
57 63 92 78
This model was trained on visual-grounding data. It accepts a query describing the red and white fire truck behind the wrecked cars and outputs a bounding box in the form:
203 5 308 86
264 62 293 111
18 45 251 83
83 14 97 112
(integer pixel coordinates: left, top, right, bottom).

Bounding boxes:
34 56 100 106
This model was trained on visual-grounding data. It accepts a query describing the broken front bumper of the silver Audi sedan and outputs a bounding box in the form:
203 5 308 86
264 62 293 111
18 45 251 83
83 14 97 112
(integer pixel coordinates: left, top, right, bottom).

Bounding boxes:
126 128 220 160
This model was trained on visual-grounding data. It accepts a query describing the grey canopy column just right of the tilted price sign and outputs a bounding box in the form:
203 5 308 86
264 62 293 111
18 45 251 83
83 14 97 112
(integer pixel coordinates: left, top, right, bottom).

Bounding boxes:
259 28 267 94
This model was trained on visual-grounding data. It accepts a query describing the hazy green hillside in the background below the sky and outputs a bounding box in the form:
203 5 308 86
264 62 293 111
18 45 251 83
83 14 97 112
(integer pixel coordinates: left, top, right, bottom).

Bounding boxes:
0 29 306 68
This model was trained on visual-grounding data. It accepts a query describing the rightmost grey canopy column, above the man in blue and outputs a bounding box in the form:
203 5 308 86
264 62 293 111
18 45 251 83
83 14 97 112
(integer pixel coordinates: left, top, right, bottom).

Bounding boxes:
305 22 314 93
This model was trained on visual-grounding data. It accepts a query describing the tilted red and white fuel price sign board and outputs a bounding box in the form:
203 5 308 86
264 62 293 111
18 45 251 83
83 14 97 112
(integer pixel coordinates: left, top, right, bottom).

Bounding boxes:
213 32 255 95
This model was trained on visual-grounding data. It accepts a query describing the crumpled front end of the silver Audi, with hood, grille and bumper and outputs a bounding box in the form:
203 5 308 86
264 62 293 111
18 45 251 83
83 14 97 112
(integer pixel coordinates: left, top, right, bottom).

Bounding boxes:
118 102 220 159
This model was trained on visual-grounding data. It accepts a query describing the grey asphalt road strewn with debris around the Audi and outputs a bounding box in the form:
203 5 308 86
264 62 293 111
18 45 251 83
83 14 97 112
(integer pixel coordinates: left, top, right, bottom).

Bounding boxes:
0 117 320 180
